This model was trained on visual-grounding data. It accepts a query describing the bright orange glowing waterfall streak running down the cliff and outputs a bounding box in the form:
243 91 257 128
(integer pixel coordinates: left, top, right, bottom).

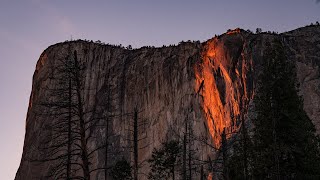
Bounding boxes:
195 35 247 147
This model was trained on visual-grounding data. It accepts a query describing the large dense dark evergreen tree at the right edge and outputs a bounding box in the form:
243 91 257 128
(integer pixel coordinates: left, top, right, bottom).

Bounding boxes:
252 40 320 179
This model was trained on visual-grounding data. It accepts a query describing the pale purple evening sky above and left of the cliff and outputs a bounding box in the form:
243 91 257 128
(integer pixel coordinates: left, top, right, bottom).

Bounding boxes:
0 0 320 180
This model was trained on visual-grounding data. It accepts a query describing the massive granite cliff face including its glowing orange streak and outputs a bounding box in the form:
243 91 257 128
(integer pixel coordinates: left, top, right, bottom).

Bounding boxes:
16 27 320 180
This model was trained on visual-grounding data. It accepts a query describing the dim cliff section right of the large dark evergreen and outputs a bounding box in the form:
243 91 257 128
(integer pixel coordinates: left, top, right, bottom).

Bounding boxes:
284 26 320 134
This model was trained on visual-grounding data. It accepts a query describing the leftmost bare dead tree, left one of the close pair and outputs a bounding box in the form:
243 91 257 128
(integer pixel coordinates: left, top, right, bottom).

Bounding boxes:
32 49 86 179
